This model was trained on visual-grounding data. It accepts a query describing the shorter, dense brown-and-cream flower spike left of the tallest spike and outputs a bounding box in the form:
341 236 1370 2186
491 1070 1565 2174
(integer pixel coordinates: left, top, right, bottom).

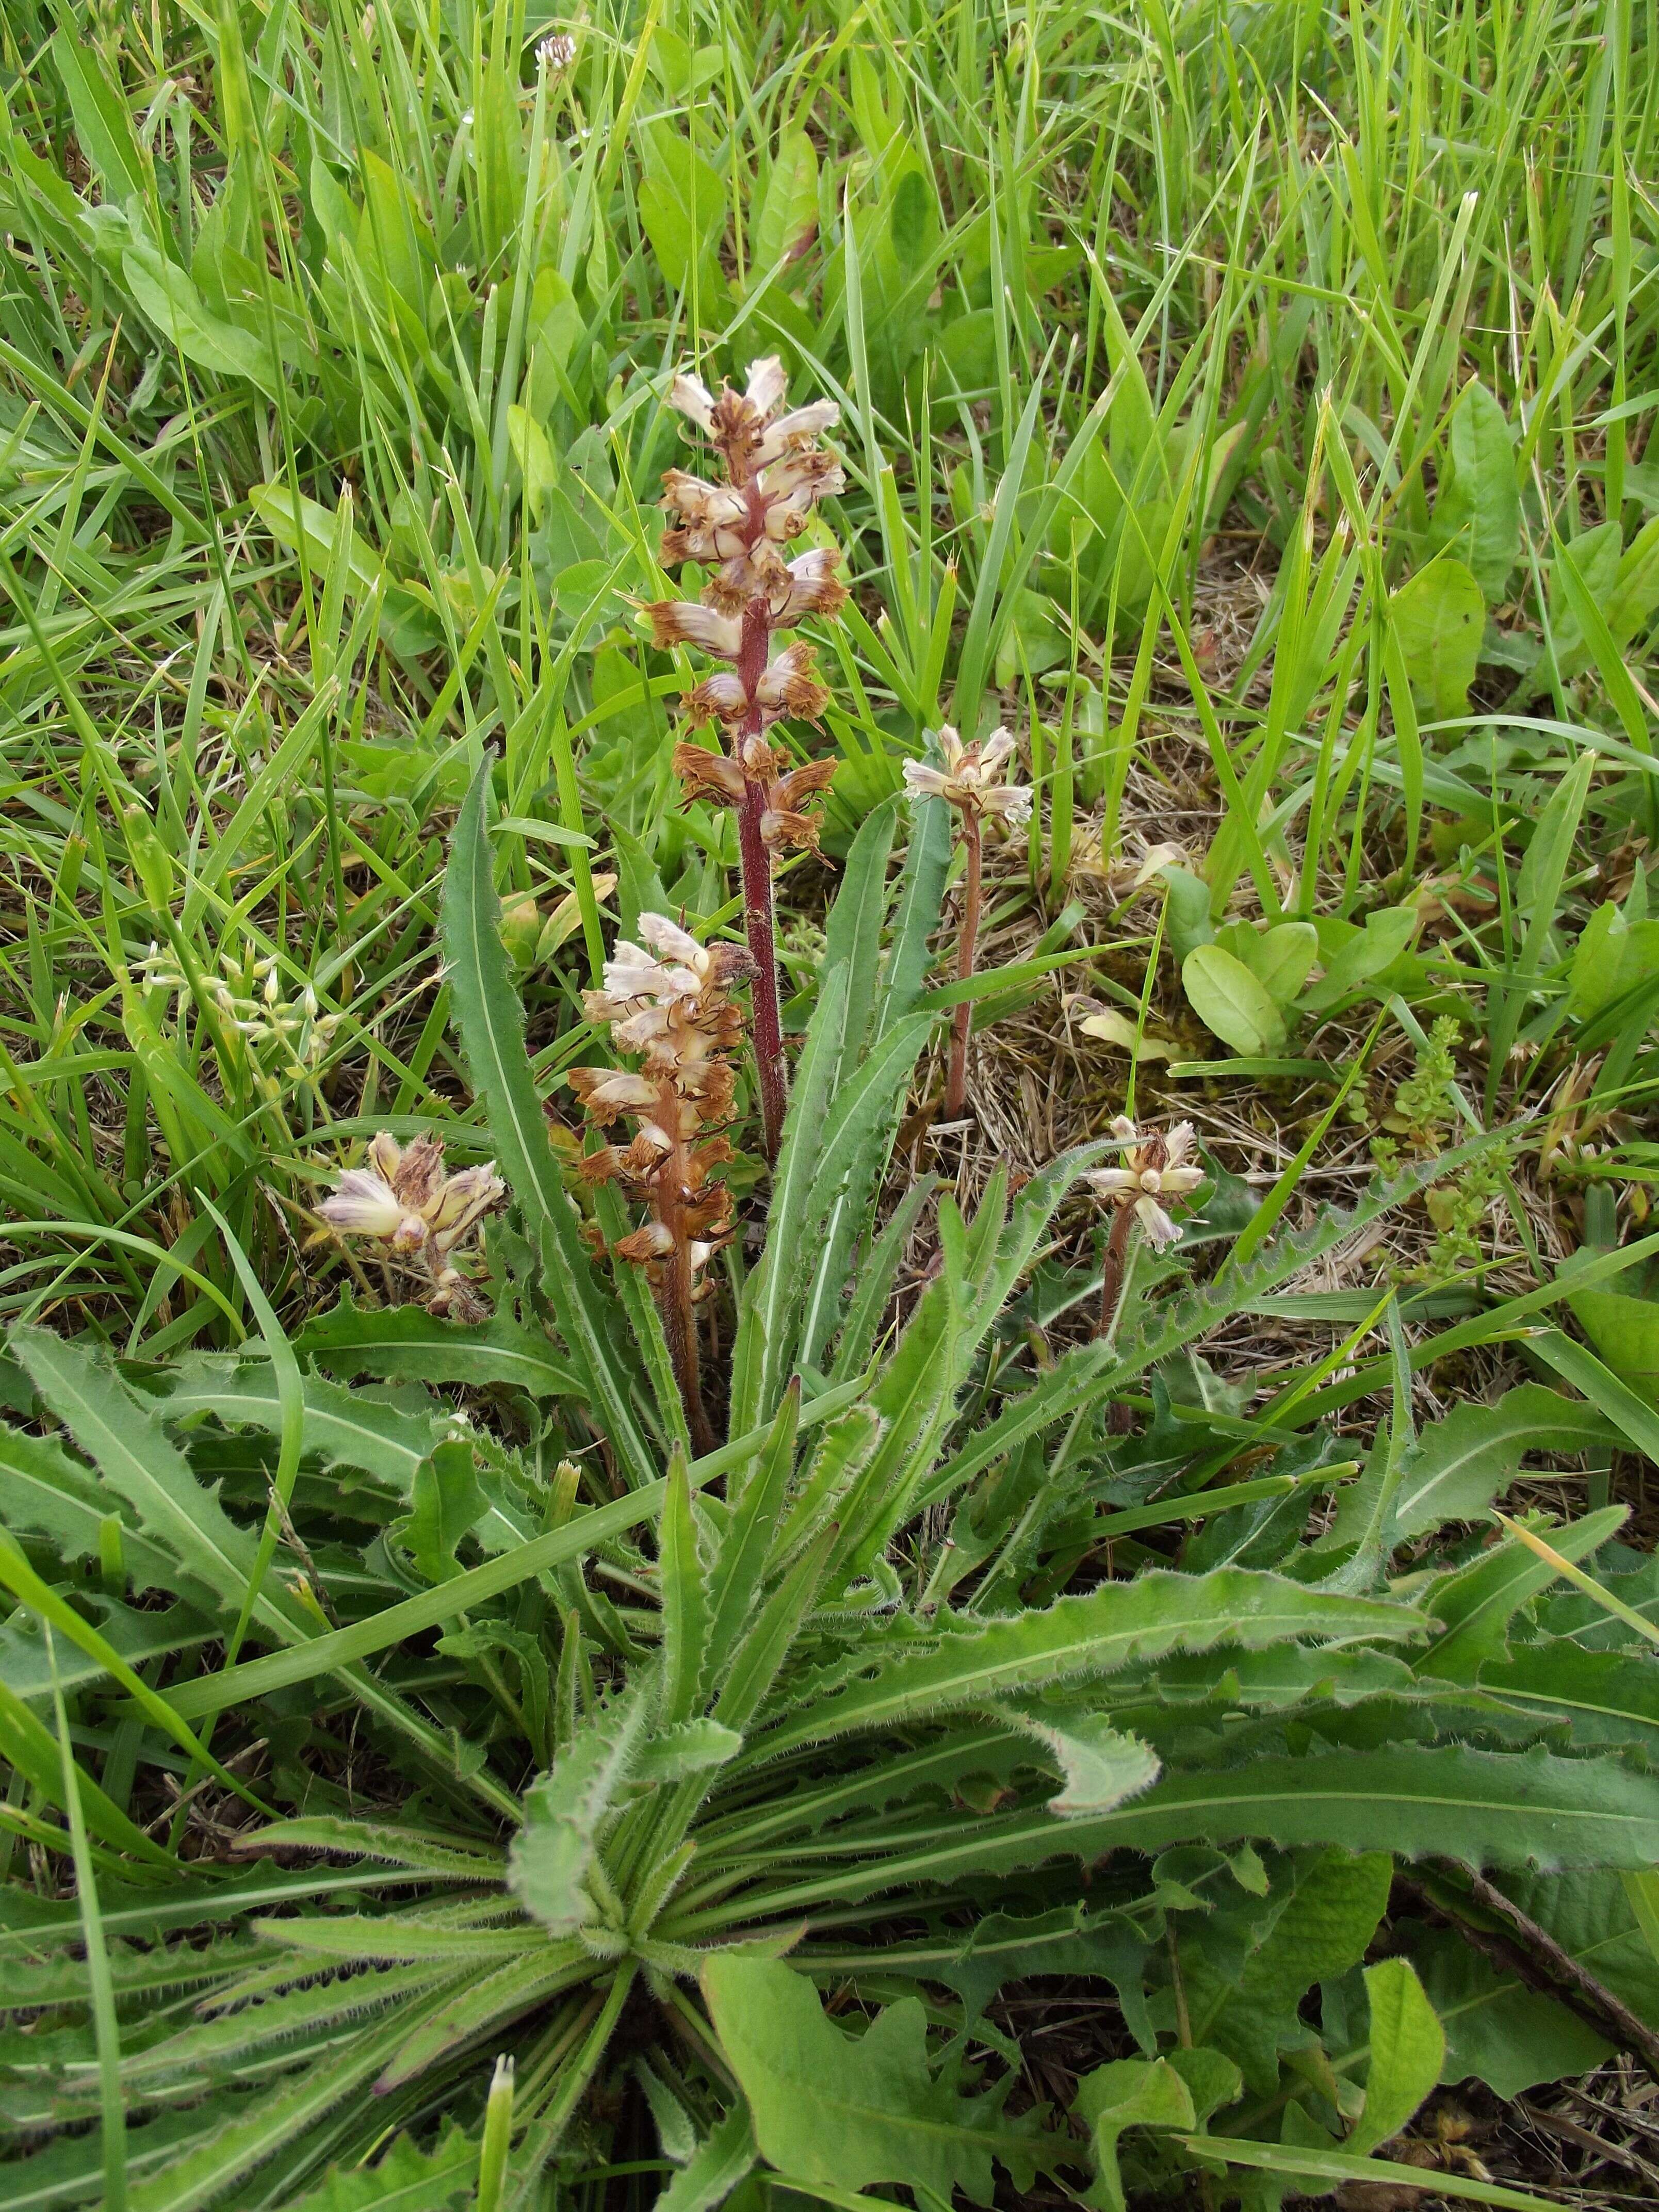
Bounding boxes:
566 914 754 1451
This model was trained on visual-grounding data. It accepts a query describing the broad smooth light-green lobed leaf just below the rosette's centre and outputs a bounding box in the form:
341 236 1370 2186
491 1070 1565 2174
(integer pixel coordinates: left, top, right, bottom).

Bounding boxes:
701 1951 1033 2203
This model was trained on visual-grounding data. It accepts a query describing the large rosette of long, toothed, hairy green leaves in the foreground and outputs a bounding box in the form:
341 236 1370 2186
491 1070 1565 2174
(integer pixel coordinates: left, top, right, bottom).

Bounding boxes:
0 781 1659 2212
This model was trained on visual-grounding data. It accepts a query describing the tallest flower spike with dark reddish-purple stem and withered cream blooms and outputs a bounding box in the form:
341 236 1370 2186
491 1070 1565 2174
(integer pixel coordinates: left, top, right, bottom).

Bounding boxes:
644 354 847 1161
